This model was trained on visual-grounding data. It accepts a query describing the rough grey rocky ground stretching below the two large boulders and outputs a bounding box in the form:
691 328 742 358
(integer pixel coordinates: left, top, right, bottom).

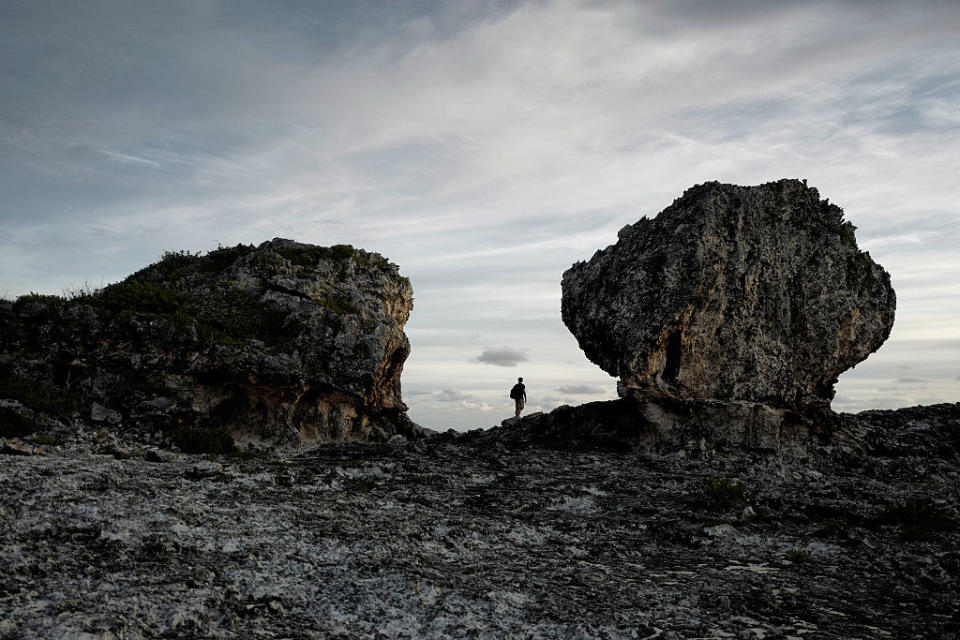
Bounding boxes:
0 405 960 639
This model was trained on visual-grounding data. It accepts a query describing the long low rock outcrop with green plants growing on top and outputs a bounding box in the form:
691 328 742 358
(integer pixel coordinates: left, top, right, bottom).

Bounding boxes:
0 239 418 449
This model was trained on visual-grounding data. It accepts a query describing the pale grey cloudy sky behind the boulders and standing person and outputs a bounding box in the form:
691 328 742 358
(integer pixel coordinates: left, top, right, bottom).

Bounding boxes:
0 0 960 428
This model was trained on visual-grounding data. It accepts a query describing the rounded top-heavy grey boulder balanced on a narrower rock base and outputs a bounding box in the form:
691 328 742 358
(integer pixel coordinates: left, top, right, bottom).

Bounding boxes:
562 180 896 411
